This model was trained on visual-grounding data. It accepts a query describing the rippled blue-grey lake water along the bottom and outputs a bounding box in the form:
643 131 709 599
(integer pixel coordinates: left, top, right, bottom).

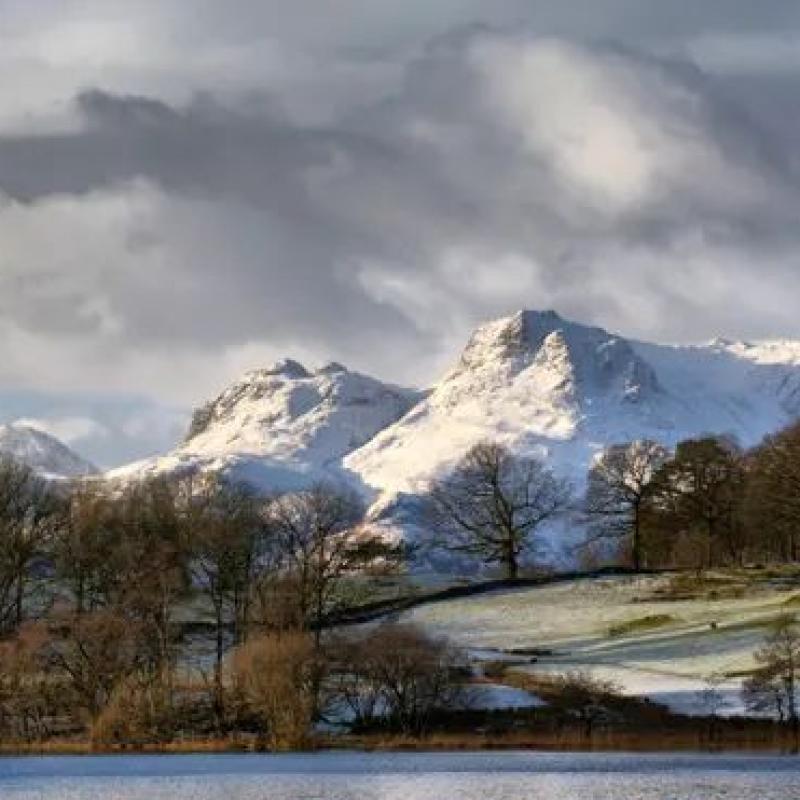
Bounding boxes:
0 752 800 800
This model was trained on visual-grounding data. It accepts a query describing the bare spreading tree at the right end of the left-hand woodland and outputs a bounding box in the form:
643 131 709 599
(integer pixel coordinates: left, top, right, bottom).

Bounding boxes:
267 484 402 645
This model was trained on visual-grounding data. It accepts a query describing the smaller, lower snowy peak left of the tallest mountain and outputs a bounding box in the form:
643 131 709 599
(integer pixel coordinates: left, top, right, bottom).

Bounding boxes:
107 360 421 490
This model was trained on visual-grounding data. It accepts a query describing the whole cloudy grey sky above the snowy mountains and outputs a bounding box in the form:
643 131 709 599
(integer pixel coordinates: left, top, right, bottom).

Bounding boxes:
0 0 800 466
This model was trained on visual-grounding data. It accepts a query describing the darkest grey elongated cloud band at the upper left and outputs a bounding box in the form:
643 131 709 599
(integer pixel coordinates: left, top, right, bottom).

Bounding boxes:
0 90 346 205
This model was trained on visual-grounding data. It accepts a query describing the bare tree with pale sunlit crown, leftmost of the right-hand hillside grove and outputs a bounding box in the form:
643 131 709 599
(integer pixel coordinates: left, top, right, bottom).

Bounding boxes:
584 439 669 570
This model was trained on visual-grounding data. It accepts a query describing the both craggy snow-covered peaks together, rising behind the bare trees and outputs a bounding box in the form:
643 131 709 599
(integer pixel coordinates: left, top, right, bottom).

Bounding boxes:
108 311 800 560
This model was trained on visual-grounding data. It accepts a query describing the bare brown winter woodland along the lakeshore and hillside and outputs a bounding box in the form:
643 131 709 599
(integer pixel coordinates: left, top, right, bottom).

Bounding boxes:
0 424 800 749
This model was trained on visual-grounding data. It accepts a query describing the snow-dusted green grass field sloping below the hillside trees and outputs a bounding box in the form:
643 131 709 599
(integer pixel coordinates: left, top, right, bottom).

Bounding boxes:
403 575 798 714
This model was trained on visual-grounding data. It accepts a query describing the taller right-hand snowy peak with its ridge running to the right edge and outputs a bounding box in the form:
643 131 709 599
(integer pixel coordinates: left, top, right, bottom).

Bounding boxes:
344 311 800 548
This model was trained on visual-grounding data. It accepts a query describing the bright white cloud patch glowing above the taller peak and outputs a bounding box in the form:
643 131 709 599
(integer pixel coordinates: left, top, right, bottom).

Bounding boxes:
470 36 780 217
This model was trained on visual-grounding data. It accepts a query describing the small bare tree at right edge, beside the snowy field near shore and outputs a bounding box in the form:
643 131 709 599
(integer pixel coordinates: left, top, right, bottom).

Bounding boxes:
742 616 800 739
